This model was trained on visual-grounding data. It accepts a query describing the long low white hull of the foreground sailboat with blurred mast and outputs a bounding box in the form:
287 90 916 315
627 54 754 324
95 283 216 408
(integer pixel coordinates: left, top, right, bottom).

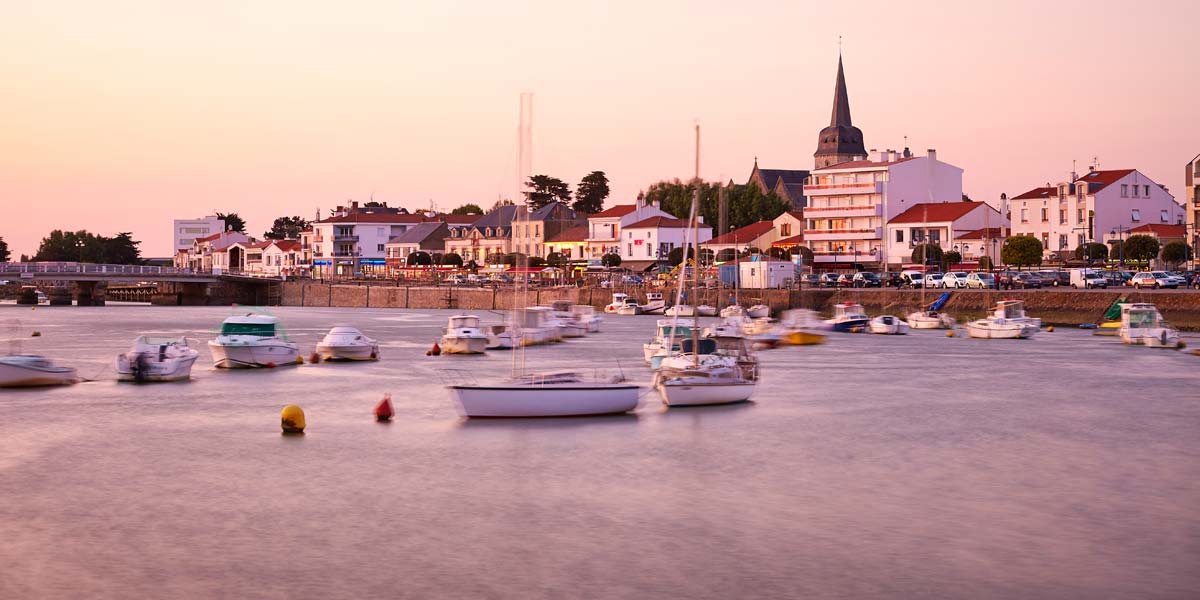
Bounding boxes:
450 373 641 418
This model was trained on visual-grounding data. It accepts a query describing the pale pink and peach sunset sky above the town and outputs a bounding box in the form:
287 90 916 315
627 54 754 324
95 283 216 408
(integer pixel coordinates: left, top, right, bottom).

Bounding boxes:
0 0 1200 257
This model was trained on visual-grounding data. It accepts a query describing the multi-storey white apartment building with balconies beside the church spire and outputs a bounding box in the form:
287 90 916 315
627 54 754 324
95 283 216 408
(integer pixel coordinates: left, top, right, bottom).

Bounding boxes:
804 150 962 268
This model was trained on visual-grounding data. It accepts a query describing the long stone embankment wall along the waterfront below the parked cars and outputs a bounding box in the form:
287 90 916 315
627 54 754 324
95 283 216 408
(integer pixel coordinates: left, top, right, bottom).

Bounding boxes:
278 282 1200 330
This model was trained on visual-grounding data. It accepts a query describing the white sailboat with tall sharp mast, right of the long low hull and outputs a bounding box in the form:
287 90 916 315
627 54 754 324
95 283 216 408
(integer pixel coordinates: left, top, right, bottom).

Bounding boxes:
654 125 758 407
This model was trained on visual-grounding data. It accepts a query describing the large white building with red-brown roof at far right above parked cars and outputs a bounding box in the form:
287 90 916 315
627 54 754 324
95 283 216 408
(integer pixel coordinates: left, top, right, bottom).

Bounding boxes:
1008 168 1187 258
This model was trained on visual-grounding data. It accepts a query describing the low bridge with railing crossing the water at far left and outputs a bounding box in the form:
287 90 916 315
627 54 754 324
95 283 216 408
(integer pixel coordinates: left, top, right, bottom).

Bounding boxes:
0 263 283 306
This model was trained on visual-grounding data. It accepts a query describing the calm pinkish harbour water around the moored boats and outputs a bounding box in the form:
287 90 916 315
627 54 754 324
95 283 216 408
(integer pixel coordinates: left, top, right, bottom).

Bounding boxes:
0 305 1200 599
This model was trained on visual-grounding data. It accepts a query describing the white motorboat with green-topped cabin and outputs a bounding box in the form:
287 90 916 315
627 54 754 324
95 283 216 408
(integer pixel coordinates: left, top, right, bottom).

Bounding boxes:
209 314 300 368
